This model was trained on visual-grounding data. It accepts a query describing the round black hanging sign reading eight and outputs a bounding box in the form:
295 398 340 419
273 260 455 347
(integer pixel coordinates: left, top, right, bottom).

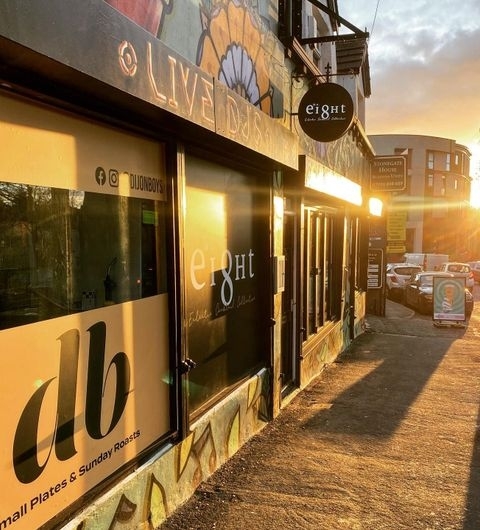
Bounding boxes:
298 83 353 142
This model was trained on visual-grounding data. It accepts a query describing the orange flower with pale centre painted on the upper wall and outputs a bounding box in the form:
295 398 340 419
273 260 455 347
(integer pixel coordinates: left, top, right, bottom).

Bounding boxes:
197 0 273 115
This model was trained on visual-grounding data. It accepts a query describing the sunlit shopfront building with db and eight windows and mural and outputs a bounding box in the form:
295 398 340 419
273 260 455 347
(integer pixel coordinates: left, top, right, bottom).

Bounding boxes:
0 0 373 530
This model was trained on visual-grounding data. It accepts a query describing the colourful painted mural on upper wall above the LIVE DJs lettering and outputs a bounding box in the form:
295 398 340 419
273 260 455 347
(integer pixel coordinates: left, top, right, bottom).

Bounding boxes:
107 0 283 117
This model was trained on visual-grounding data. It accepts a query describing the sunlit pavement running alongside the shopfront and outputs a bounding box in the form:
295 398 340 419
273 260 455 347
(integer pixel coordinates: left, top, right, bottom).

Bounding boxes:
160 301 480 530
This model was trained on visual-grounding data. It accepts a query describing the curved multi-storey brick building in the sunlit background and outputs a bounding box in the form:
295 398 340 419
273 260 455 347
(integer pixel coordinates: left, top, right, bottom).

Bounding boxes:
369 134 476 262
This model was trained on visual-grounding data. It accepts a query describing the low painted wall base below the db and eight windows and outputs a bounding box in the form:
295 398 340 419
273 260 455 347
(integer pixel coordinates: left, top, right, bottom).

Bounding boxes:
63 370 271 530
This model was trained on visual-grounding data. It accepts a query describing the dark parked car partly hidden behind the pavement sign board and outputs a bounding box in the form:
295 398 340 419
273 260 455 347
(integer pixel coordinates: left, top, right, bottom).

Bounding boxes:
405 271 473 317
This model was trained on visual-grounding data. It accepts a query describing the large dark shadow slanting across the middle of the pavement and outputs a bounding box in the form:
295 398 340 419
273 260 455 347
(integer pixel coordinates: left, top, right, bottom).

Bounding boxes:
306 333 452 437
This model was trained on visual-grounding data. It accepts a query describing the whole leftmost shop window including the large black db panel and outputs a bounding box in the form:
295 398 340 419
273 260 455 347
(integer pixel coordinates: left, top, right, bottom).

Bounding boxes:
0 94 172 528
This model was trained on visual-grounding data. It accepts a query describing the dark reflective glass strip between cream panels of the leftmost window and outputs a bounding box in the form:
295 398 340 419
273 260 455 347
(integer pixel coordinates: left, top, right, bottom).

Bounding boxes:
0 182 166 329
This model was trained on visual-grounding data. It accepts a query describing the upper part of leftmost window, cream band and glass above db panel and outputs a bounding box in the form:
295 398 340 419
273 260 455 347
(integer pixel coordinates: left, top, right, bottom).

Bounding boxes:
0 95 166 329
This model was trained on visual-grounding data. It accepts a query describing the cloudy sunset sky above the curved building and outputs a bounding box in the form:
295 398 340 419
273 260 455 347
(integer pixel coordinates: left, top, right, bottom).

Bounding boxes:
338 0 480 185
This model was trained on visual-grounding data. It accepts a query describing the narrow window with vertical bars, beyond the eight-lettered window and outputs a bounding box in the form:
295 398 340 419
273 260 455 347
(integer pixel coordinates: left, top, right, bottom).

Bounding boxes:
302 207 340 340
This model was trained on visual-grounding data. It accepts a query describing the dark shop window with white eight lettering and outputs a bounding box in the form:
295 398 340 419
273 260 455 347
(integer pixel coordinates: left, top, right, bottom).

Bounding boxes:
185 157 270 412
